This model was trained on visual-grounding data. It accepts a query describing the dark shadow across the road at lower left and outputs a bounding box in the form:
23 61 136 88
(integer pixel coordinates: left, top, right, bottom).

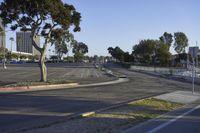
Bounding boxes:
0 93 110 133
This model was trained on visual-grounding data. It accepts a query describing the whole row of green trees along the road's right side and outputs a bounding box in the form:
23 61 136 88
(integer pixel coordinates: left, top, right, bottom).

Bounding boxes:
108 32 188 66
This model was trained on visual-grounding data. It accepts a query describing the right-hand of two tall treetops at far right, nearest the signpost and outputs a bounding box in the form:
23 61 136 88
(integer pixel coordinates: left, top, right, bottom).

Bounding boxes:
174 32 188 54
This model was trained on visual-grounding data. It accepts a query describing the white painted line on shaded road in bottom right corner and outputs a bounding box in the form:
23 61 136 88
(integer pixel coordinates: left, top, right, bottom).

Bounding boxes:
147 105 200 133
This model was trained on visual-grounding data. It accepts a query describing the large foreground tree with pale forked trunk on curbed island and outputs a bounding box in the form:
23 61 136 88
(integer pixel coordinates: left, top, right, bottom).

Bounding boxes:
0 0 81 81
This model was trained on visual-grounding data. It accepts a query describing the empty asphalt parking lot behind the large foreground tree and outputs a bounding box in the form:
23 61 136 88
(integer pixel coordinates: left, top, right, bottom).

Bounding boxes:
0 63 114 85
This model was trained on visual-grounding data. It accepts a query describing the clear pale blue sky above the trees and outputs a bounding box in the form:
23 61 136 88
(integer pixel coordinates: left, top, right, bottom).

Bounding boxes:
0 0 200 56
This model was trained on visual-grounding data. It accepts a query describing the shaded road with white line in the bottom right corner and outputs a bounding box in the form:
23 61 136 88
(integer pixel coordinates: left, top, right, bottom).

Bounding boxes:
125 100 200 133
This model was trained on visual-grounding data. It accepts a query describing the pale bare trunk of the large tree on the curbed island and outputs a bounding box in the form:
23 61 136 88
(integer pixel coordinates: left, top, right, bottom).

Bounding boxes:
39 50 47 82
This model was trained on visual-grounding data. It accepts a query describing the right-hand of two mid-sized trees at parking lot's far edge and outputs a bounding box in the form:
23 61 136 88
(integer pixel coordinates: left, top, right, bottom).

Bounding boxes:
72 41 88 62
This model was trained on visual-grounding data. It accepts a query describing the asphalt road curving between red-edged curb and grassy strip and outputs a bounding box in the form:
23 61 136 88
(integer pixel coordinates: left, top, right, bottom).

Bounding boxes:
0 64 200 133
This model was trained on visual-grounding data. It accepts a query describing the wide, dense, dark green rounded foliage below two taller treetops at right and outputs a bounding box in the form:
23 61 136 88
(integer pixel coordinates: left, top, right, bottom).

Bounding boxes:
133 39 171 66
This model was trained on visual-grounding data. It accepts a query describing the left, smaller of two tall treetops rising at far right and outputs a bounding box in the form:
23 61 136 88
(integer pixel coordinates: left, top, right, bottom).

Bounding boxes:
160 32 173 50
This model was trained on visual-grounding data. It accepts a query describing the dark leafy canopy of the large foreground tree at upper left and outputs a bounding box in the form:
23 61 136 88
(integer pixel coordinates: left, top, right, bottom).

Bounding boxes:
0 0 80 33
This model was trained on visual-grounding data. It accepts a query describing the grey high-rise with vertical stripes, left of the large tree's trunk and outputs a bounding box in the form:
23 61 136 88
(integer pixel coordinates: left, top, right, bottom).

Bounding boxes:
16 31 40 55
